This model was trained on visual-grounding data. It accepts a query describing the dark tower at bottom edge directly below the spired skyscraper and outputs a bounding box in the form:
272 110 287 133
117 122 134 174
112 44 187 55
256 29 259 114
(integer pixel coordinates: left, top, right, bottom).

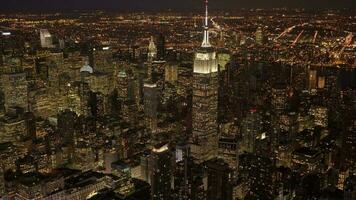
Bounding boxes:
205 158 233 200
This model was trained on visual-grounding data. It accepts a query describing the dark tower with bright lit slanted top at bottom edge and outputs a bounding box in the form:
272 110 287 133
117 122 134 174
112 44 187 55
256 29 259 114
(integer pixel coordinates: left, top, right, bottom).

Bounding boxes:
150 144 172 200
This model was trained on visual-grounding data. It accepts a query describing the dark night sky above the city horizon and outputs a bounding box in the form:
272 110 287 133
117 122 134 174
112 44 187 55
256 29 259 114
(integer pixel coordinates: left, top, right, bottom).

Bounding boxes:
0 0 356 11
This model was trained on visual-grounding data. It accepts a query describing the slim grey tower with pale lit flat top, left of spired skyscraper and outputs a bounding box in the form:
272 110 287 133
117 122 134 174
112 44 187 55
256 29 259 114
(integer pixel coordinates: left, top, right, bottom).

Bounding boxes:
143 83 158 133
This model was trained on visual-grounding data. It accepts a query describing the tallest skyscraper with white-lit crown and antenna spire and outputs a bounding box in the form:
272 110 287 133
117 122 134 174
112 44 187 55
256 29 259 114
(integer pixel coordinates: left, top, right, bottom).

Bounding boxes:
191 1 218 162
